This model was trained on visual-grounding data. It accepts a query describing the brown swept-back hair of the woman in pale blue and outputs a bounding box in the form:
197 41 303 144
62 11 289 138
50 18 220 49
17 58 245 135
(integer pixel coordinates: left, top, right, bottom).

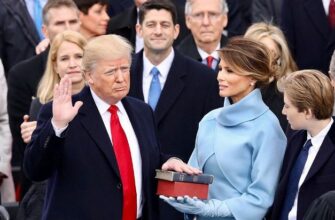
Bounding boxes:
219 37 275 87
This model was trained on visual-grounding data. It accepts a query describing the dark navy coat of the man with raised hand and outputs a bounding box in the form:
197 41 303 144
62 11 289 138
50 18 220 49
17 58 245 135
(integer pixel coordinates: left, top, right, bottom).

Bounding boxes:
24 87 165 220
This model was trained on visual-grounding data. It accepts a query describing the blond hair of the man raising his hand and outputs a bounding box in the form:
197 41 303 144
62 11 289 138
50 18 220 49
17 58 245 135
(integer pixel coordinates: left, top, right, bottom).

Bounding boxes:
82 34 133 73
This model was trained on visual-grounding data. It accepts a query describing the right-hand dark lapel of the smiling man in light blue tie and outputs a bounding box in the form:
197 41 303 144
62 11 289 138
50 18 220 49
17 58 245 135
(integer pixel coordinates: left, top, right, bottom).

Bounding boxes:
155 51 186 125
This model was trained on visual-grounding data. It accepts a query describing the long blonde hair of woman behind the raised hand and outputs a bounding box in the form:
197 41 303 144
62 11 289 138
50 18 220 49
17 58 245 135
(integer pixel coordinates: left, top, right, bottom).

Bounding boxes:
37 31 87 104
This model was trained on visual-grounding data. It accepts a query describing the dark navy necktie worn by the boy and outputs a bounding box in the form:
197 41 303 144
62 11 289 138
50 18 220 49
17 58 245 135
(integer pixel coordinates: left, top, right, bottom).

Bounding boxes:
280 139 312 220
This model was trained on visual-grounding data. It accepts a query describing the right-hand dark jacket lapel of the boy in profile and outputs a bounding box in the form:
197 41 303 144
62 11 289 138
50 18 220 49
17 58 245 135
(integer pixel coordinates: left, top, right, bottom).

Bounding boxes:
304 123 335 182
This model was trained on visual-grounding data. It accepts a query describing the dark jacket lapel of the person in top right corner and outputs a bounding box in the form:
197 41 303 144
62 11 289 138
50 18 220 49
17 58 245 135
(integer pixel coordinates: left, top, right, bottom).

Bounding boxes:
303 0 330 40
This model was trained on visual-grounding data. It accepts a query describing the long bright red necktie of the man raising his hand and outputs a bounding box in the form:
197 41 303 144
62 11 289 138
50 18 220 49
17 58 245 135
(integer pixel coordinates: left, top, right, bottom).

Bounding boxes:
108 105 137 220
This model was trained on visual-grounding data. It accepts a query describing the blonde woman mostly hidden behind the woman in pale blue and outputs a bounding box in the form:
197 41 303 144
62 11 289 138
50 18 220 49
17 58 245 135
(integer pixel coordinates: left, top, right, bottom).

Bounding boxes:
244 22 297 130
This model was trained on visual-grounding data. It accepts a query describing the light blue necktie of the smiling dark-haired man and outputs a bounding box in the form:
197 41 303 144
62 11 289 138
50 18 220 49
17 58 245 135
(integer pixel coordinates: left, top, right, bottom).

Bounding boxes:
148 67 161 110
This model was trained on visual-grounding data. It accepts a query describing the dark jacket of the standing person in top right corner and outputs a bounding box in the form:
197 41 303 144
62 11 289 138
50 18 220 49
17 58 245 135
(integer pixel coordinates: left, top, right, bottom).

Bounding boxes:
281 0 335 74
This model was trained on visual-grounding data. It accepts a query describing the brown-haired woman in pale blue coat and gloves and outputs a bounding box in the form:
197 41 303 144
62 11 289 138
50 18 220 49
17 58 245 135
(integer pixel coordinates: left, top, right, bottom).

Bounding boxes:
162 38 286 220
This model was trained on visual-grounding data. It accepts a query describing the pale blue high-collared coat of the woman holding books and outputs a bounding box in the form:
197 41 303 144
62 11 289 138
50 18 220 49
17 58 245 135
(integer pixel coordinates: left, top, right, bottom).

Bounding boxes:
186 89 286 220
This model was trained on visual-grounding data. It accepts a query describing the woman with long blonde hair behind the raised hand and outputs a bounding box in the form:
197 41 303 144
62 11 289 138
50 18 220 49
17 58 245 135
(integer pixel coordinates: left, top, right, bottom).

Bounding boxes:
21 31 86 143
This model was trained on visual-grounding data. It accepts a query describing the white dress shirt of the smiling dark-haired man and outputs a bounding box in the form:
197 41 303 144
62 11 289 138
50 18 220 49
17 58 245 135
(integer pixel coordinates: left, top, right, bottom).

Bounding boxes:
143 49 174 103
